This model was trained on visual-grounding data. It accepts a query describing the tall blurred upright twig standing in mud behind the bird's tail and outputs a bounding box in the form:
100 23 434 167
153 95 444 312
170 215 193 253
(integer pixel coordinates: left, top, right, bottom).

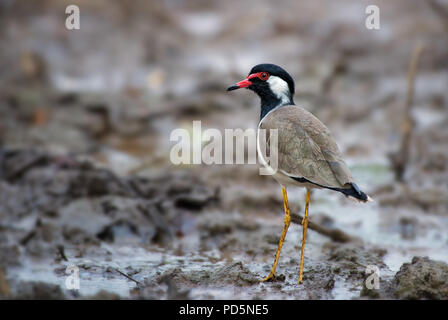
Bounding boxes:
389 44 423 182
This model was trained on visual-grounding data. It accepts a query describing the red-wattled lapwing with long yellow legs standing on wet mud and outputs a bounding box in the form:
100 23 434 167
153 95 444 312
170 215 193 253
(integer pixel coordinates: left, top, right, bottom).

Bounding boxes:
227 63 372 284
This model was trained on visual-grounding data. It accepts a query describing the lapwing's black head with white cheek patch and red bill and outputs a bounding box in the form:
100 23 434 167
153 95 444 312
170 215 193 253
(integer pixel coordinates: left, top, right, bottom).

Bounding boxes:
227 63 294 107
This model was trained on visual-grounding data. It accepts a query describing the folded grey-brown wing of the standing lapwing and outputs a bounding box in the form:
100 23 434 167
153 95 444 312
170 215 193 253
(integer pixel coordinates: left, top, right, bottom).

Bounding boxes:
260 106 353 188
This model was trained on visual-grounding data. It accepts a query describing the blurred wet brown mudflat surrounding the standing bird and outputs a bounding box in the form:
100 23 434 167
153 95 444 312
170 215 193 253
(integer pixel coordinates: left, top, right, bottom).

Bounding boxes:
0 0 448 299
